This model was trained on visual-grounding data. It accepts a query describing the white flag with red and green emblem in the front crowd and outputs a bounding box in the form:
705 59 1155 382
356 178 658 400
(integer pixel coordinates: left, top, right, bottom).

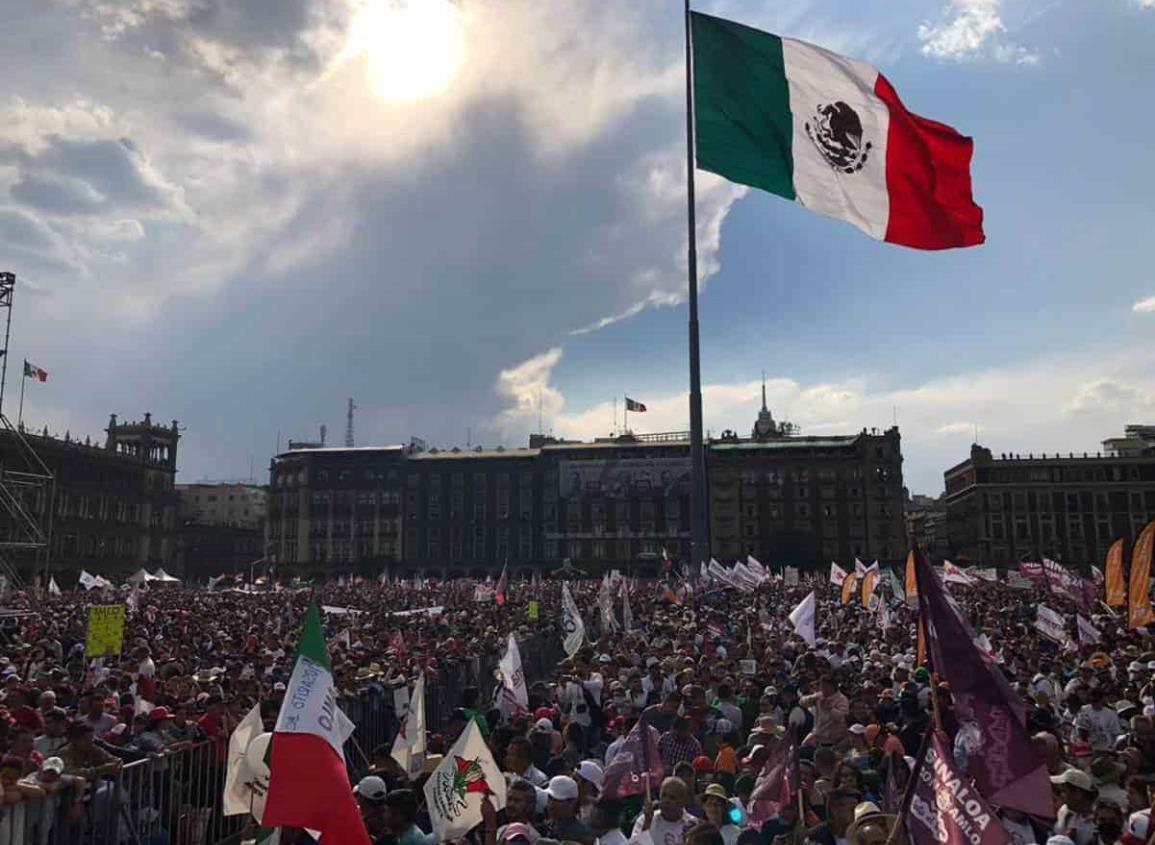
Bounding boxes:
425 719 506 842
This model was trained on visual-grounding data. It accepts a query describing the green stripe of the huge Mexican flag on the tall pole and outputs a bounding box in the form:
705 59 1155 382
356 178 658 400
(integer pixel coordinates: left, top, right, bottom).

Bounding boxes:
691 12 795 200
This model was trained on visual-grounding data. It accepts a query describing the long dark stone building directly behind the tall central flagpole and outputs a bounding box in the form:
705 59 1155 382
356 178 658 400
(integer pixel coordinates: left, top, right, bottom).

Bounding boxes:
267 399 906 575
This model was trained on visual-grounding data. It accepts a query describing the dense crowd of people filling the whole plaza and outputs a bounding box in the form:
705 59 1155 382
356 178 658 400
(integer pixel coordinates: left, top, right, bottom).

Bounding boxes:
0 567 1155 845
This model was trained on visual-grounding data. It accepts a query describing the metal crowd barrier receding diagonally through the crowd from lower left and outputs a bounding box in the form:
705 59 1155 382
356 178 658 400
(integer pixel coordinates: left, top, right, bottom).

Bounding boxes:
0 637 561 845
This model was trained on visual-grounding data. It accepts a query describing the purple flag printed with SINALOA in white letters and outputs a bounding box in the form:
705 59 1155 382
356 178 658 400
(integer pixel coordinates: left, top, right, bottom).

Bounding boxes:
907 731 1011 845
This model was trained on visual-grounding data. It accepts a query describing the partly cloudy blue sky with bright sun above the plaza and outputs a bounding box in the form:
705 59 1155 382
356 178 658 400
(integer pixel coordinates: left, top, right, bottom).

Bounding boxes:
0 0 1155 494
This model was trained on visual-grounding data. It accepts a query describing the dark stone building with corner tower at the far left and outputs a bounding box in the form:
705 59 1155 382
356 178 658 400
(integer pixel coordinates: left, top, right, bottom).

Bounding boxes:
0 414 180 586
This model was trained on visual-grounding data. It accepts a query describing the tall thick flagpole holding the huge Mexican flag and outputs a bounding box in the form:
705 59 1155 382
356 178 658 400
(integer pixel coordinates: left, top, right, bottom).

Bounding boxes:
684 0 710 570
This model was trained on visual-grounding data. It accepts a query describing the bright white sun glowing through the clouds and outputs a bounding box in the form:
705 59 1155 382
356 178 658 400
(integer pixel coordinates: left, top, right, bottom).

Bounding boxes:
342 0 465 103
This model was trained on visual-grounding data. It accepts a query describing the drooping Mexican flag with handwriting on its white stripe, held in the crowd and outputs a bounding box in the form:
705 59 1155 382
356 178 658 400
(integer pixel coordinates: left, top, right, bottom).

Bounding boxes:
261 605 370 845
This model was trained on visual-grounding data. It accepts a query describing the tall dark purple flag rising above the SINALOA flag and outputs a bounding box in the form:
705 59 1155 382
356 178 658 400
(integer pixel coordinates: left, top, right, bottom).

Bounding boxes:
915 554 1055 818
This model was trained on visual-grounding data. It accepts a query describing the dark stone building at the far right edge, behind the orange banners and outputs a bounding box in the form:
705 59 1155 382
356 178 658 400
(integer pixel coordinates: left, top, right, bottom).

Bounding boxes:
945 431 1155 567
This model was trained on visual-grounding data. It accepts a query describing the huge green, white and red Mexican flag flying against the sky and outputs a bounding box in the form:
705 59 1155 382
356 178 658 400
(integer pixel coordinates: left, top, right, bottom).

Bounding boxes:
692 12 984 249
